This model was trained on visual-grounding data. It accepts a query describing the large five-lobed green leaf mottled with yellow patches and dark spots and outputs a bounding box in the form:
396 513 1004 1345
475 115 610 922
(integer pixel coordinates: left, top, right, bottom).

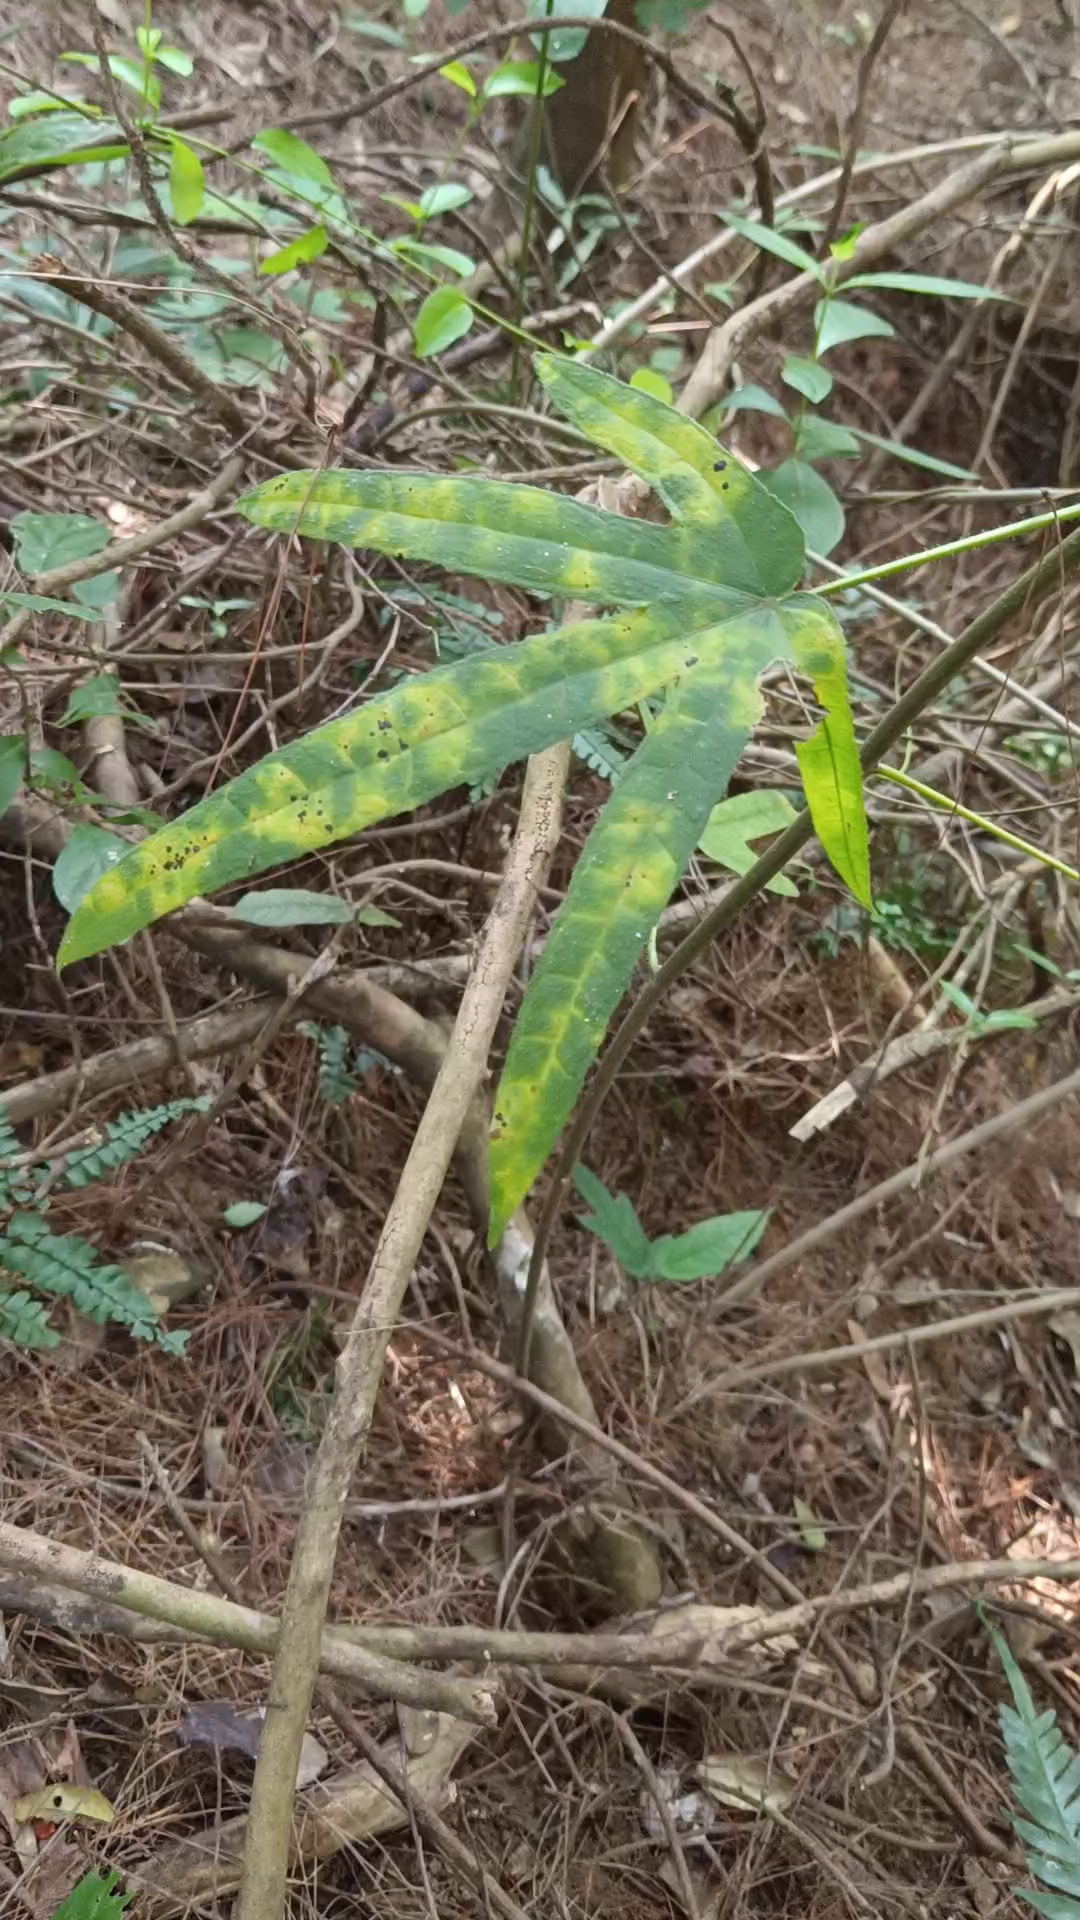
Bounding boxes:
60 353 869 1236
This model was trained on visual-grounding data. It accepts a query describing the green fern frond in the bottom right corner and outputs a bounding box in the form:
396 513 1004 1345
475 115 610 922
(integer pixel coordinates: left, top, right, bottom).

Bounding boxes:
986 1620 1080 1920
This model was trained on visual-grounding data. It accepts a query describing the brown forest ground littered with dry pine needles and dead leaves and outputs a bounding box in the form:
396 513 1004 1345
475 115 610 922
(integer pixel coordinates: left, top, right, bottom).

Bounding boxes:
0 0 1080 1920
